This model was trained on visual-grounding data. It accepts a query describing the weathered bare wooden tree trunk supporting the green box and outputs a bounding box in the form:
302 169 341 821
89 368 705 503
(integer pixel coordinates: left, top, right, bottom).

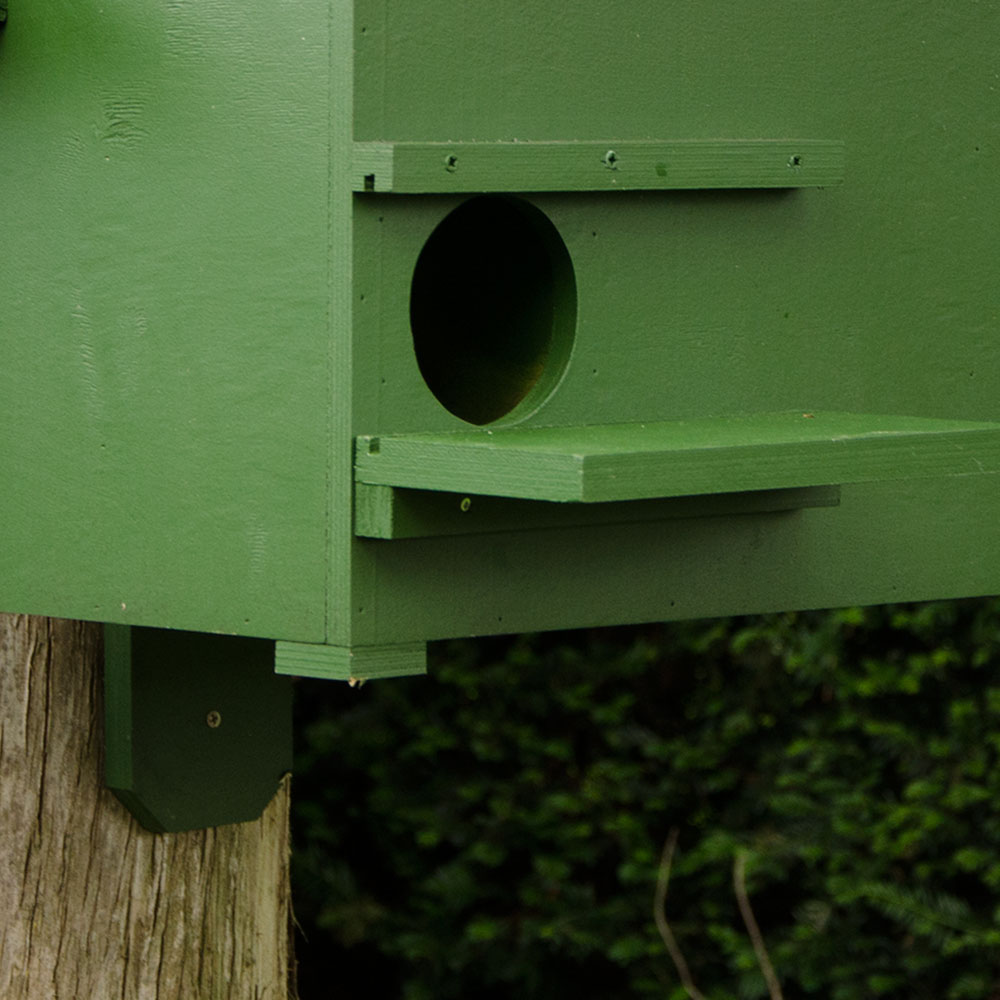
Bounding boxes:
0 615 290 1000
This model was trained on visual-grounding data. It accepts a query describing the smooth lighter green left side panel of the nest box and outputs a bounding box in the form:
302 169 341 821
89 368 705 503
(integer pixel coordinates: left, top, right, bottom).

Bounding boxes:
0 0 331 641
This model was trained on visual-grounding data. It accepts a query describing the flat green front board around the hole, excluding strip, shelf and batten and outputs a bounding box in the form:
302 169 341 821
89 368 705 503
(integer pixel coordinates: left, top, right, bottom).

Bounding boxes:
350 0 1000 643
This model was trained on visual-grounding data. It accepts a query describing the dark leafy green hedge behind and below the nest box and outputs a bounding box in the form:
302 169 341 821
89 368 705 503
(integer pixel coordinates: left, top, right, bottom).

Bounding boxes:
293 600 1000 1000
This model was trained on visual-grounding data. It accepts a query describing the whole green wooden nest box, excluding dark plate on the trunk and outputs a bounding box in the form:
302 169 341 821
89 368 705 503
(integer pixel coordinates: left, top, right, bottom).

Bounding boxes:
0 0 1000 828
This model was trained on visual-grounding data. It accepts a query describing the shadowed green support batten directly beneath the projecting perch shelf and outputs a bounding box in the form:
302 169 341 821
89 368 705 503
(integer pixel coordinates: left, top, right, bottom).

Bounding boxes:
354 483 840 539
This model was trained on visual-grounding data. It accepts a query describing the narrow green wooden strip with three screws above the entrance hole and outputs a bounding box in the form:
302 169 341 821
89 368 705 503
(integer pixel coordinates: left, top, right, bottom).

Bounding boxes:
352 139 844 194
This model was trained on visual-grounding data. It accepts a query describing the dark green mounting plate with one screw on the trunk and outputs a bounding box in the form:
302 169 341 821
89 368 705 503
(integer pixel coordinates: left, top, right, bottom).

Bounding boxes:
104 625 292 833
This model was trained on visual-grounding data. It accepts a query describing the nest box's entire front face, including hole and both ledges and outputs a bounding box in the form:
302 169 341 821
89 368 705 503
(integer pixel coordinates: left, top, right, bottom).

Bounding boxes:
345 0 1000 643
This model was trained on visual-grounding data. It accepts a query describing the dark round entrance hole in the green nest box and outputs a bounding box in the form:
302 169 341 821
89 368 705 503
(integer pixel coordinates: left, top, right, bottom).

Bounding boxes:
410 195 576 424
